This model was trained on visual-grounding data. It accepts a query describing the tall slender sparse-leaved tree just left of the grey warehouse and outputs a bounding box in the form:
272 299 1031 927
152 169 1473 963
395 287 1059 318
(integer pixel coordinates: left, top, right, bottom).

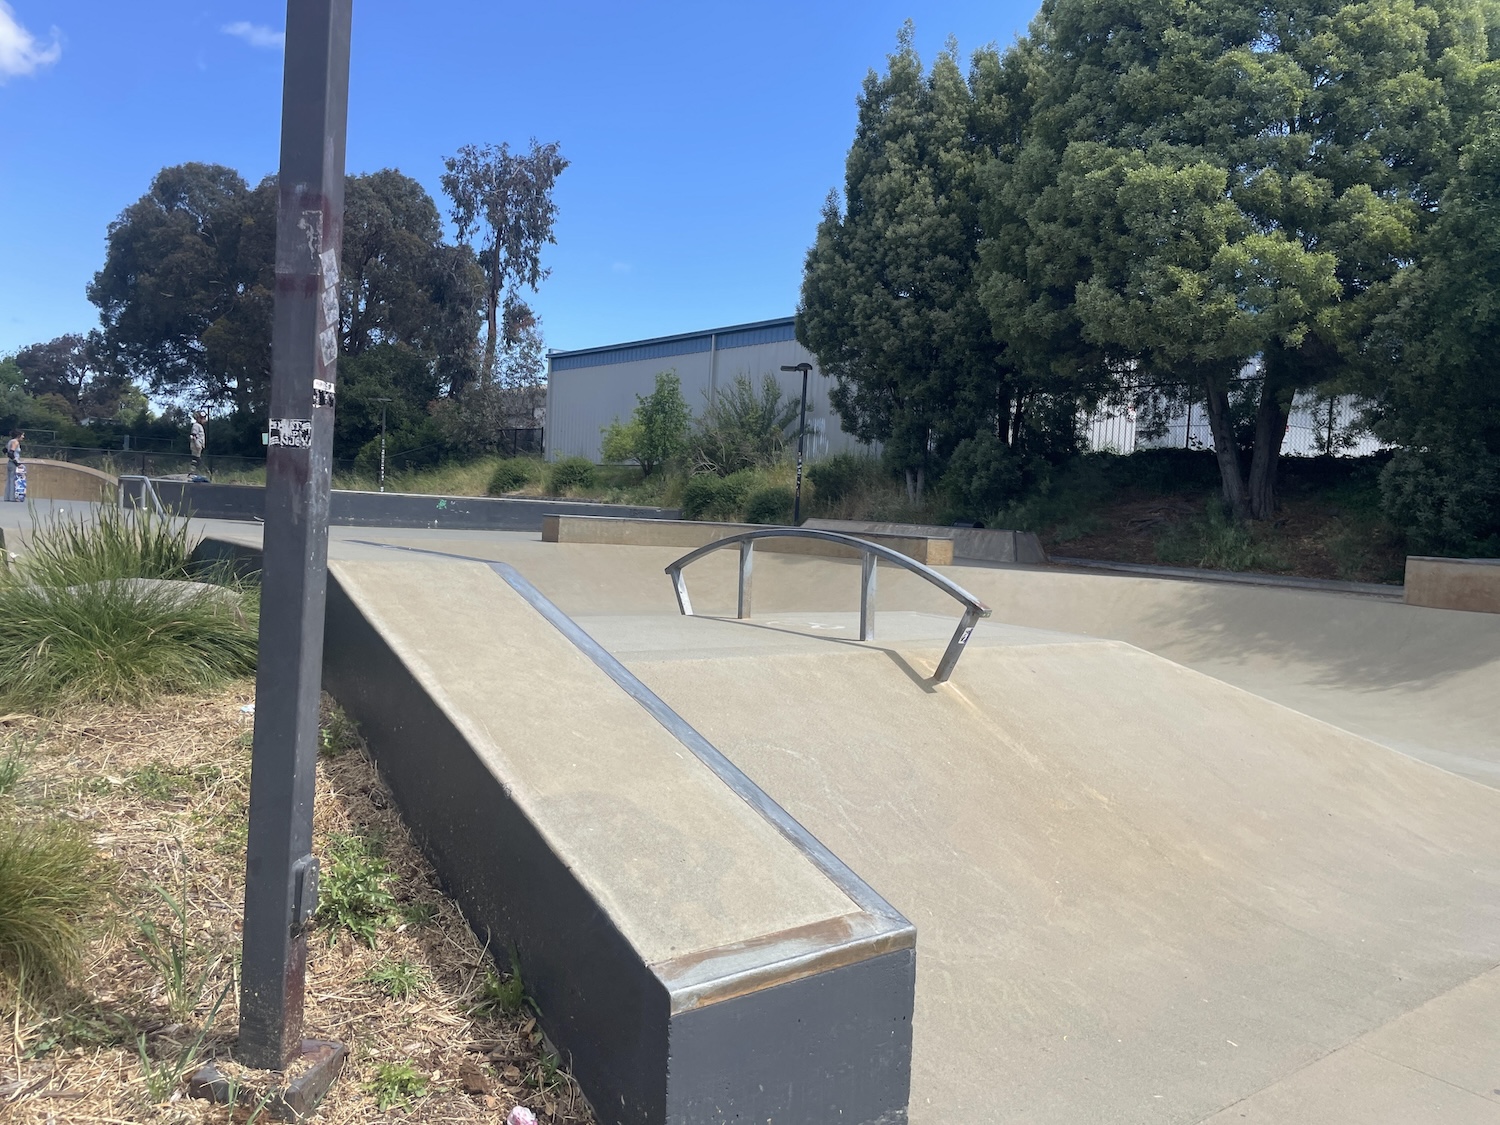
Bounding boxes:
443 140 569 377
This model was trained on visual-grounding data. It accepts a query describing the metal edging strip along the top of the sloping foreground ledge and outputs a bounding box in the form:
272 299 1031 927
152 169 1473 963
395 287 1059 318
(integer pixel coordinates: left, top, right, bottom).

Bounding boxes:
348 540 912 1011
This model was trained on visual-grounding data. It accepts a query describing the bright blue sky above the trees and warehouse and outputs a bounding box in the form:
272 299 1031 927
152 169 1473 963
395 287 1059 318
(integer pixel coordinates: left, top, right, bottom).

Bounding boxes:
0 0 1035 354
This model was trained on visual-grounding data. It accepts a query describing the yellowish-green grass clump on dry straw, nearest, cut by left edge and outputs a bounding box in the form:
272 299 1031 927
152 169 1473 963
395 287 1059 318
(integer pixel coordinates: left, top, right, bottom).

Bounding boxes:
0 818 110 987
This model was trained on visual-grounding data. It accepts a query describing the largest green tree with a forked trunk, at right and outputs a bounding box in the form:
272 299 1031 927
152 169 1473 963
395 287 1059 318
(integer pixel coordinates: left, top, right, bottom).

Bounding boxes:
990 0 1490 518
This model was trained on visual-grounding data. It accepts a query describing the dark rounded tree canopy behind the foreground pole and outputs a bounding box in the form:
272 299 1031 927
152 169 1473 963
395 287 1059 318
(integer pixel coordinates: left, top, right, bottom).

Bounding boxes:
89 164 485 456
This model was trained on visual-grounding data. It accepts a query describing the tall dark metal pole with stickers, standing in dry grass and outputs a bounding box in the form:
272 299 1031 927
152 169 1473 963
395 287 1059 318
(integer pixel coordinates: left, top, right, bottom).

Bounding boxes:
237 0 353 1070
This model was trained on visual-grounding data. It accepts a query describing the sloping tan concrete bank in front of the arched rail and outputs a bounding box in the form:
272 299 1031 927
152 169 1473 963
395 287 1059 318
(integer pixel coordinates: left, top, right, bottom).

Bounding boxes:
594 612 1500 1125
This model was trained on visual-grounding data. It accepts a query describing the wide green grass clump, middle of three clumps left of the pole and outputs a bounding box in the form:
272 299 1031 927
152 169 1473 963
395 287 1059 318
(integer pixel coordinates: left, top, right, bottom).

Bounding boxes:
0 579 257 708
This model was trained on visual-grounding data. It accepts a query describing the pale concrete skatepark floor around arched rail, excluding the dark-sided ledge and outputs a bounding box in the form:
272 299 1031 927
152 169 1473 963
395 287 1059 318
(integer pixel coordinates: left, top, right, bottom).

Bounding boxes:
11 513 1500 1125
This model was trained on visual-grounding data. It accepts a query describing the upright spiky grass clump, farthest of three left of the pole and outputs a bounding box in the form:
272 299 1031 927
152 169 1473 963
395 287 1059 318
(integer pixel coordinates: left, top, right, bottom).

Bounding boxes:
17 504 194 587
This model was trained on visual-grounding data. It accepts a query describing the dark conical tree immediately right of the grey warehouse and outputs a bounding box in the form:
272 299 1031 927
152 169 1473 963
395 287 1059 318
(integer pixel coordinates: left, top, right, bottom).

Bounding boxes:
797 23 1016 495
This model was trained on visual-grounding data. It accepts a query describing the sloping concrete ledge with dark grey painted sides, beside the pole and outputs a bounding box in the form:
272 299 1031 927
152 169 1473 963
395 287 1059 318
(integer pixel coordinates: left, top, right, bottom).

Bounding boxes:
324 555 915 1125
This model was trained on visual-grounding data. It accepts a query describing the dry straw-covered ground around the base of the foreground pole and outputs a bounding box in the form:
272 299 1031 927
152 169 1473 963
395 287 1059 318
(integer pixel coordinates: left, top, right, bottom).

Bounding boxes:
0 683 593 1125
